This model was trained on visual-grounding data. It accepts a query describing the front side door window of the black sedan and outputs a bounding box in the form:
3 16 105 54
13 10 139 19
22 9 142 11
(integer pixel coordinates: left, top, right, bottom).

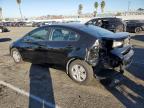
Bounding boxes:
29 28 49 41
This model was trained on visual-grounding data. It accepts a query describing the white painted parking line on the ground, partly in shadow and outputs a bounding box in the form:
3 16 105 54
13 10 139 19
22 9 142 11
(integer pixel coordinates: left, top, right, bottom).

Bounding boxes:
0 81 60 108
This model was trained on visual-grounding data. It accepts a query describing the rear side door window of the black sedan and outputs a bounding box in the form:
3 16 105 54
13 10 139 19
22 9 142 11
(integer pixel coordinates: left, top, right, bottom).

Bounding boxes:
49 28 79 41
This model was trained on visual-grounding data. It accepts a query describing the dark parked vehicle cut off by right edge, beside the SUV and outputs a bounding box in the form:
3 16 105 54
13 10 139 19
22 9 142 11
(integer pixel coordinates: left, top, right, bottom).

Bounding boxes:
125 20 144 33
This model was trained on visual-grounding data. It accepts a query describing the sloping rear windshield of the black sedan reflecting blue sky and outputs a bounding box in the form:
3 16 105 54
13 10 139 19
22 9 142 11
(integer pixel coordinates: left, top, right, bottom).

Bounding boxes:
80 25 114 37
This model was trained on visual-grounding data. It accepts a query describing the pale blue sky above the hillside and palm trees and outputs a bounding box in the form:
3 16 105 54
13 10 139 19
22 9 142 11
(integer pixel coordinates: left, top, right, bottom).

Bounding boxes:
0 0 144 18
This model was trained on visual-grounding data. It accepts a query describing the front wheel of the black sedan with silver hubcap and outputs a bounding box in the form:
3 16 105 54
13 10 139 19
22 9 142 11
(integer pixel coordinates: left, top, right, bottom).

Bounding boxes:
11 48 23 63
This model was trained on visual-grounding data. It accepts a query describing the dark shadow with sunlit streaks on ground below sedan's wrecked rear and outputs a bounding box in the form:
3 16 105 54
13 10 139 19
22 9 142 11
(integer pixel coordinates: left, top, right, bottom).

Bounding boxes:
101 69 144 108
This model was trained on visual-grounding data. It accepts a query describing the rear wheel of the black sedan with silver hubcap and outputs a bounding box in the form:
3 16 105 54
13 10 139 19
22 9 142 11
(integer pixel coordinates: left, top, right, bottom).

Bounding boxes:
68 60 94 85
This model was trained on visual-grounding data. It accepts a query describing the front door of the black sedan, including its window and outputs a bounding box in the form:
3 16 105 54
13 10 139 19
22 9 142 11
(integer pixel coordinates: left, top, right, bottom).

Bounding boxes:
22 27 49 63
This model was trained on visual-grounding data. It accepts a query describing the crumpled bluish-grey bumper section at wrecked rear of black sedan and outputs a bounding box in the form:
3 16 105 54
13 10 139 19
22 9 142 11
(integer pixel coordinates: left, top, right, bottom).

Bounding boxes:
111 45 134 68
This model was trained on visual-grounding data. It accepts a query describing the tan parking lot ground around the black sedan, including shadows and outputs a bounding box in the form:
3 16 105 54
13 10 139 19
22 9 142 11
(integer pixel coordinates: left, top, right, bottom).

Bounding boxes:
0 27 144 108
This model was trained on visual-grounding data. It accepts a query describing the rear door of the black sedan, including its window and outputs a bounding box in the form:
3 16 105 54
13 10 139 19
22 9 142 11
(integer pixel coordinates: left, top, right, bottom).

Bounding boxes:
46 27 80 64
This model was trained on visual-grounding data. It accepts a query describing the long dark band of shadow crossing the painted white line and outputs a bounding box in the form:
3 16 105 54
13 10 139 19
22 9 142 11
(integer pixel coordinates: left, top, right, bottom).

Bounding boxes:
29 64 55 108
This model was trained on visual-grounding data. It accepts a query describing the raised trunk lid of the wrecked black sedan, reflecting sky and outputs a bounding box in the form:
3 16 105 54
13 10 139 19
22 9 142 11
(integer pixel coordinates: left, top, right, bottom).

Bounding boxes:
98 32 130 40
